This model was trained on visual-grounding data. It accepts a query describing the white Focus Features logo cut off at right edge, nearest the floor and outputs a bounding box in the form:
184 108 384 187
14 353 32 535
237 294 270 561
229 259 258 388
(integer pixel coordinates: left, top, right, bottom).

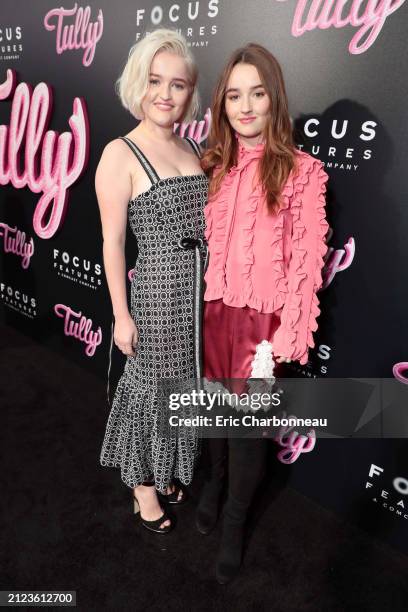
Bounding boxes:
365 463 408 519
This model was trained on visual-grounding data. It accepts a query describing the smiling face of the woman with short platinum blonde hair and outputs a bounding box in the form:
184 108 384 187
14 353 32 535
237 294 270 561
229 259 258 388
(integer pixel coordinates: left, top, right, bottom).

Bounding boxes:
142 51 192 127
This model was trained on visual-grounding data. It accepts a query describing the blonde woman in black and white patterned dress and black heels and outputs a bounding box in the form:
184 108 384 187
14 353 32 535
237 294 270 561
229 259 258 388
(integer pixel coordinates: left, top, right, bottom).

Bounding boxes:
95 29 207 534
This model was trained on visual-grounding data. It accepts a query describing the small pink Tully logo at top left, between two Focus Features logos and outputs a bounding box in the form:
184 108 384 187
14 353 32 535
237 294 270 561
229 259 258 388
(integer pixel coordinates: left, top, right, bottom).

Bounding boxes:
44 3 103 66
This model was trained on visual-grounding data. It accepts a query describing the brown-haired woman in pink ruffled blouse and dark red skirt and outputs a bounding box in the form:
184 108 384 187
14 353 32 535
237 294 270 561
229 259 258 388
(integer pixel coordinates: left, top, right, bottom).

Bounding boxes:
196 44 328 583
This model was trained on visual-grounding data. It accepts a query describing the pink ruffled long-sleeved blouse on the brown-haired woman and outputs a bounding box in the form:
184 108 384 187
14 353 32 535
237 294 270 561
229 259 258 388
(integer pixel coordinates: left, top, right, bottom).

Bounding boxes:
204 139 329 364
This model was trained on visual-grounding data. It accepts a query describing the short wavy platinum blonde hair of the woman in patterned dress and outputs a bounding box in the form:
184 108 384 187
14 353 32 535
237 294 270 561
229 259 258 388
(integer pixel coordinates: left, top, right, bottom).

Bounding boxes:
116 28 200 122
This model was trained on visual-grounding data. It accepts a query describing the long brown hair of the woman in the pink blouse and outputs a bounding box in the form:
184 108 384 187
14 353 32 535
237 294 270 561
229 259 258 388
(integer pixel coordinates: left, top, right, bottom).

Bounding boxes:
202 43 295 212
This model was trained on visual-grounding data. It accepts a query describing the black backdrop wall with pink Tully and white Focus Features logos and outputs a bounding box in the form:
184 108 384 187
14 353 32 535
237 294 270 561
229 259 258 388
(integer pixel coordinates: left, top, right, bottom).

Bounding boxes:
0 0 408 552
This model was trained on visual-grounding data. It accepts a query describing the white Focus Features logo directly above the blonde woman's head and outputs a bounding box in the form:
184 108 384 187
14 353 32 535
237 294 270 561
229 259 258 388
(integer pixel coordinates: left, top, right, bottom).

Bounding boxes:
136 0 220 47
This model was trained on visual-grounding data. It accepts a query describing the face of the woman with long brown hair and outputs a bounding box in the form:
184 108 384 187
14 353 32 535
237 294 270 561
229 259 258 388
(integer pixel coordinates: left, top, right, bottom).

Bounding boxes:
225 63 270 140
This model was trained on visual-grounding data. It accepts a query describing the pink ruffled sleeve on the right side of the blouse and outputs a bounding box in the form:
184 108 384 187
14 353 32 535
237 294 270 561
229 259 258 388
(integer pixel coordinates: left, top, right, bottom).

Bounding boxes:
273 156 329 365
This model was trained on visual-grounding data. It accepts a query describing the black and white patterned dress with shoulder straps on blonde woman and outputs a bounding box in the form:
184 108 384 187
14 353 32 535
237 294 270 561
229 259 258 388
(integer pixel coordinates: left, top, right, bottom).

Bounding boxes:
100 137 208 493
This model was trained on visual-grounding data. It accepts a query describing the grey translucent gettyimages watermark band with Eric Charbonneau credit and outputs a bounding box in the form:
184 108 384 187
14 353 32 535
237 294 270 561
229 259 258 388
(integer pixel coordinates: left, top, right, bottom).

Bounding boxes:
157 377 408 440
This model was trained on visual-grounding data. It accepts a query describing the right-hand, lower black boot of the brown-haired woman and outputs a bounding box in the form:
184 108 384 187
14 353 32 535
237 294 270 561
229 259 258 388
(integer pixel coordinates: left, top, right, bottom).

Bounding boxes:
215 495 248 584
